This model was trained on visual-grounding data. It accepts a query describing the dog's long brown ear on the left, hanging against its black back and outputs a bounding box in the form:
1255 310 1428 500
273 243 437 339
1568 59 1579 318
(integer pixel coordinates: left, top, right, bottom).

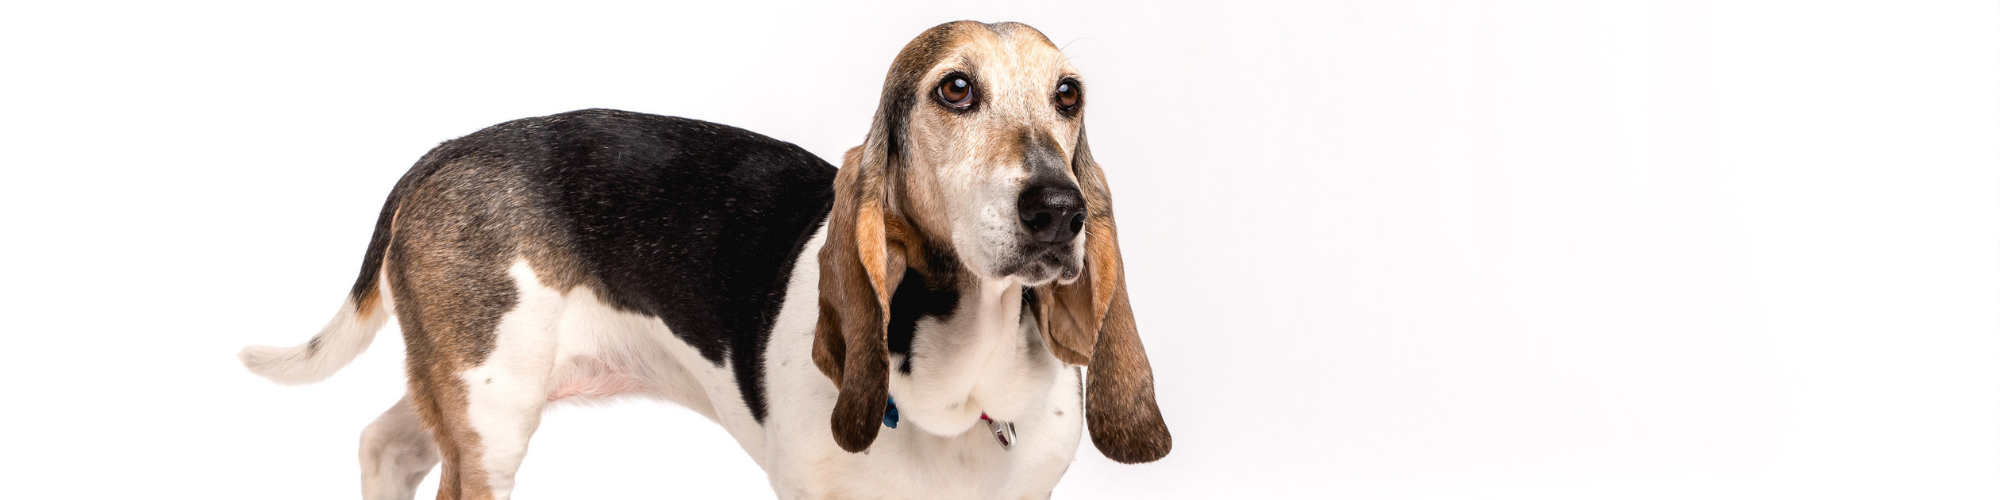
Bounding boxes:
812 144 904 452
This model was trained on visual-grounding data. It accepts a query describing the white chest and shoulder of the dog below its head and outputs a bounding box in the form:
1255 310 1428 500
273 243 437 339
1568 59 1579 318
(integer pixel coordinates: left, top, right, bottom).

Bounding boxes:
746 230 1084 498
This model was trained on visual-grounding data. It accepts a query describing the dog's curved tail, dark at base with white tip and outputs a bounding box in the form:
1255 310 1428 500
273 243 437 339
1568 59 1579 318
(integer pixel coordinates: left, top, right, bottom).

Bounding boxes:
236 186 404 386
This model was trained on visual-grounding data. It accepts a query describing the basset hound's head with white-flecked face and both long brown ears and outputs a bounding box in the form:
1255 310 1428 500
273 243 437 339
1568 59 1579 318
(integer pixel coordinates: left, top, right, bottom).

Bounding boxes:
812 22 1172 462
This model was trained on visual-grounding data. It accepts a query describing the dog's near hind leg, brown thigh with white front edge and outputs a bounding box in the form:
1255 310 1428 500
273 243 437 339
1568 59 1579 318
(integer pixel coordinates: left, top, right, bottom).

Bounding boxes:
384 162 582 500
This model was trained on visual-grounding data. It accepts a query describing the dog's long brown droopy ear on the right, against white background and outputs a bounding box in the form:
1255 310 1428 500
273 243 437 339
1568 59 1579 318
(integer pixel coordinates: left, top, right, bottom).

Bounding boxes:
1036 127 1174 464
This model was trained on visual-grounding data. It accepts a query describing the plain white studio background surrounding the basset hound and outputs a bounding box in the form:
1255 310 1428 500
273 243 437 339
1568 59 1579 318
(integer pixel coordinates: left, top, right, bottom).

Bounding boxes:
0 2 2000 498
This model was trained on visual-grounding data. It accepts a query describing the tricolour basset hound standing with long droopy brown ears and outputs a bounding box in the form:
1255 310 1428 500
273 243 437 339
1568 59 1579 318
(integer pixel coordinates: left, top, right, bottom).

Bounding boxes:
240 22 1172 500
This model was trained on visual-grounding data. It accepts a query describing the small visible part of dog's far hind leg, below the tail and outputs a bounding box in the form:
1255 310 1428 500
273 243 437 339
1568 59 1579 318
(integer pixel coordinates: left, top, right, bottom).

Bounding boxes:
362 396 438 500
